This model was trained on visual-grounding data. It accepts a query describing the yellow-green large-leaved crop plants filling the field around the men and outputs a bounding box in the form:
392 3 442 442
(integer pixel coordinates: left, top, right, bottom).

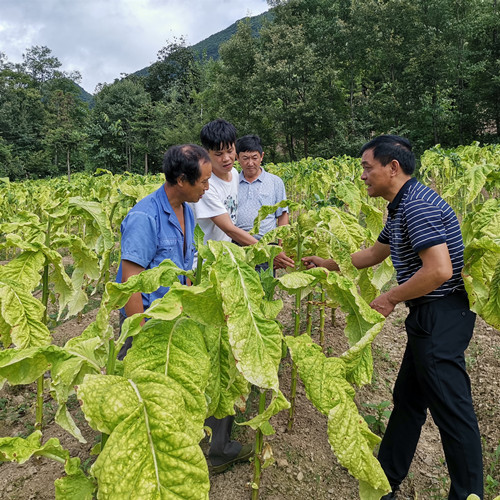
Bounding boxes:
0 145 500 500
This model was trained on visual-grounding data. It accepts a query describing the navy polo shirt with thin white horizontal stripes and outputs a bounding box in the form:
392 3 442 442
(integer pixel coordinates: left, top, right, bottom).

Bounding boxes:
378 178 464 299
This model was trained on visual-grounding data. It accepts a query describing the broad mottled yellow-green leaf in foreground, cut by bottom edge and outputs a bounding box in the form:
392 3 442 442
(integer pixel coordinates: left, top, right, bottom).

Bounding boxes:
78 371 210 500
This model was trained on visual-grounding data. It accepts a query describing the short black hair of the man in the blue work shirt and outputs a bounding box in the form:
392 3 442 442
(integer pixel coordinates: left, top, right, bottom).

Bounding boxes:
162 144 210 186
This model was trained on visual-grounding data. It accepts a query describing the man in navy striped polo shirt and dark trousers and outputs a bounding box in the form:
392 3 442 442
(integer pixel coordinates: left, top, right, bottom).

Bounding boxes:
303 135 483 500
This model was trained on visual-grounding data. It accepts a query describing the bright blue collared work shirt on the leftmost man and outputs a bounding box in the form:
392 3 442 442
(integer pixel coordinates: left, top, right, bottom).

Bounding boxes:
116 186 195 314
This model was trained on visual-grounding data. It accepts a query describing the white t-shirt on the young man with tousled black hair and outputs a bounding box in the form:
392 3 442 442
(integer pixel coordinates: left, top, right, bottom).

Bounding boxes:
191 167 239 243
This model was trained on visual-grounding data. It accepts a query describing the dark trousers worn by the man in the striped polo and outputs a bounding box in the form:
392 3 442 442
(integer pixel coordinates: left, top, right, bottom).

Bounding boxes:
378 294 483 500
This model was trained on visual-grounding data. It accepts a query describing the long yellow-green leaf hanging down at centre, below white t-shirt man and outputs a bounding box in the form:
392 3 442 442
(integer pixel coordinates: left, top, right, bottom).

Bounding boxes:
208 241 282 391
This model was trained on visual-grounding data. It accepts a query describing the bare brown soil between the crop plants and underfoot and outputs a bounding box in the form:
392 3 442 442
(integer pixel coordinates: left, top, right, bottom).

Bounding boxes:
0 297 500 500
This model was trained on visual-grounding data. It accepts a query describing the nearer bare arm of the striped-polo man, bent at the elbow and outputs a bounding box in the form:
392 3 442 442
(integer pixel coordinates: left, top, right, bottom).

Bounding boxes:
370 243 453 317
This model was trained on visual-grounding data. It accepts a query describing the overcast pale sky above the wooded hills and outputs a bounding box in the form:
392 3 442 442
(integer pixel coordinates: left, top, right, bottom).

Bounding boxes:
0 0 268 93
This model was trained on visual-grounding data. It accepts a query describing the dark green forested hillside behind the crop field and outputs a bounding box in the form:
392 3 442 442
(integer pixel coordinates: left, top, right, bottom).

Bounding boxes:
0 0 500 180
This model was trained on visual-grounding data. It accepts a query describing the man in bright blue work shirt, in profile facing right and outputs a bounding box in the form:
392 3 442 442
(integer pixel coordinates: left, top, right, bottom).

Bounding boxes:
116 144 212 359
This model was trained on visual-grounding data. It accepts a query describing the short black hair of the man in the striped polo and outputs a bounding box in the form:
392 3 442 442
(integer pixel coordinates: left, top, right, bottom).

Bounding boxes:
361 135 415 175
